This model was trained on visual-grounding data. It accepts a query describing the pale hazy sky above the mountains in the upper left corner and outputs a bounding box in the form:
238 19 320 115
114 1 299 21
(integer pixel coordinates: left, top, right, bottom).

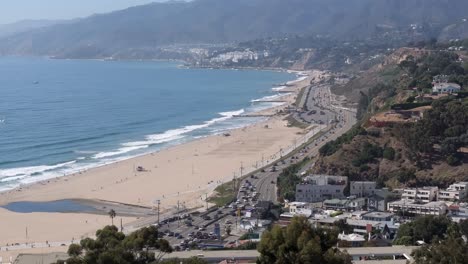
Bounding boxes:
0 0 163 24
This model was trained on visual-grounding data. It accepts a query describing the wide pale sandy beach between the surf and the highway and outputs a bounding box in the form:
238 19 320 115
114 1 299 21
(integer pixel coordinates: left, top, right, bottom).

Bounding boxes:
0 71 326 257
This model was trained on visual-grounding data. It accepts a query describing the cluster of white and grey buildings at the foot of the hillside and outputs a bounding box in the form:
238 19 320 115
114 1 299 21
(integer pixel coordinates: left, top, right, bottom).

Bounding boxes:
280 175 468 246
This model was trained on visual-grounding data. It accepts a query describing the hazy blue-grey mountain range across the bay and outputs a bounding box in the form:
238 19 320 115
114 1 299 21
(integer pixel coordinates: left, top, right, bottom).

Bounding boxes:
0 0 468 58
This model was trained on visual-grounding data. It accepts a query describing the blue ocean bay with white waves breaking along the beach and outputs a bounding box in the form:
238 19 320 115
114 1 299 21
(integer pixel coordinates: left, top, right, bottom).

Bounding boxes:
0 58 295 190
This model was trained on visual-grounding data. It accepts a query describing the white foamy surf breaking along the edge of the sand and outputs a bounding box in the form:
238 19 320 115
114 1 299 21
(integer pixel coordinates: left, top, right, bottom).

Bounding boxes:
0 63 304 194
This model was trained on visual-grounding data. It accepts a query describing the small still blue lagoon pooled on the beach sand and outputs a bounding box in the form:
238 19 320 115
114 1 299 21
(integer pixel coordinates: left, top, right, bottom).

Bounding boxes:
2 200 97 213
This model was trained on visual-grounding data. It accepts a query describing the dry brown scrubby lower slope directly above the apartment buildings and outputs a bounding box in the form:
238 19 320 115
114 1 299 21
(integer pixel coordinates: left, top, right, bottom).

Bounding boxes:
313 129 468 188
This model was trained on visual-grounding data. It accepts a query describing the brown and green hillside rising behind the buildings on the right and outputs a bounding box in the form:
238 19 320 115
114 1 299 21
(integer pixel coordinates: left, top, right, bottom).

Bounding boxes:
314 47 468 188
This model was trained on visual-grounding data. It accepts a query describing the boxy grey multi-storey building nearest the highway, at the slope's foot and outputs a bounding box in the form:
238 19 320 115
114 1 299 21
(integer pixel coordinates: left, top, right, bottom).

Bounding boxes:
296 175 348 203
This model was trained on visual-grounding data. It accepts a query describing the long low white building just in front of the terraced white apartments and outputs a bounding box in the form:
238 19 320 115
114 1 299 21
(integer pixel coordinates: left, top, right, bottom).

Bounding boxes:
388 199 448 215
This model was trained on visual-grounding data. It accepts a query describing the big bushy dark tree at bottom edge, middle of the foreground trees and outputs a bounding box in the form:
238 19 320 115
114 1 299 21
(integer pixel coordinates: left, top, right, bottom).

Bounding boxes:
257 217 351 264
